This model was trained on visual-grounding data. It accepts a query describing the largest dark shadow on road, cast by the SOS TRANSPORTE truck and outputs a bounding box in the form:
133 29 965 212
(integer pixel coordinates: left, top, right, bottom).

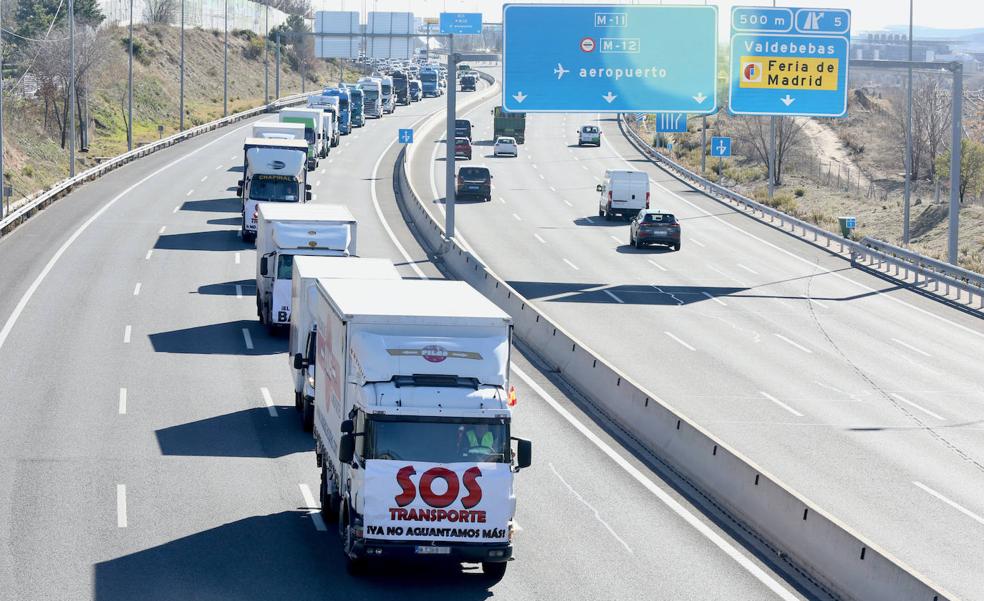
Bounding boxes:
93 511 492 601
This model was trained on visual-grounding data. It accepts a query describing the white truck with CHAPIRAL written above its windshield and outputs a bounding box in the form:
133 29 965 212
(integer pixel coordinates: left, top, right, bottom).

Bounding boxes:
236 138 311 242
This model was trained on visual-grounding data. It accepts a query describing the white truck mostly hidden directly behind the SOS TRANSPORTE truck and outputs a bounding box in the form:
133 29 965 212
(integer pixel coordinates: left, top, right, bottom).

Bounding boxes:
288 256 400 432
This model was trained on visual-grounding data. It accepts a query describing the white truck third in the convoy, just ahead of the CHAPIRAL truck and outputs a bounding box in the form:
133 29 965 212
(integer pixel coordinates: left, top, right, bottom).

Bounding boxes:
256 203 356 332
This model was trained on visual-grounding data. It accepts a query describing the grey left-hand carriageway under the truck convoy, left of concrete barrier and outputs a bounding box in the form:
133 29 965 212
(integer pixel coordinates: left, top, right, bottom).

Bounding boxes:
0 77 808 601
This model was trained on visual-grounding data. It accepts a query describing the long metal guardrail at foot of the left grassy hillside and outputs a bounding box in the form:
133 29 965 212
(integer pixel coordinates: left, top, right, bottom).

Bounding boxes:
0 94 308 236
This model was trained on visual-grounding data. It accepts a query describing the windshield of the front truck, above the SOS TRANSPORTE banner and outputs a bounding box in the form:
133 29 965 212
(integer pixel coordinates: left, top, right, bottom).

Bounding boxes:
365 416 509 463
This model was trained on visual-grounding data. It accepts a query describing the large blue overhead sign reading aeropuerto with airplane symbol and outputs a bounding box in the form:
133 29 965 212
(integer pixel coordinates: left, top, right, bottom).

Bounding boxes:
502 4 717 114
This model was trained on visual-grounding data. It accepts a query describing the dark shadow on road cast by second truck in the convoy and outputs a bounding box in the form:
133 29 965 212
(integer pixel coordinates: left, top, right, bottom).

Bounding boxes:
154 407 314 458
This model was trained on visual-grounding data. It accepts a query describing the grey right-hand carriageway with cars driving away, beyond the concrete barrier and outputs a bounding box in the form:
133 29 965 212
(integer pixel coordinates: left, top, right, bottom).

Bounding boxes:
410 71 984 599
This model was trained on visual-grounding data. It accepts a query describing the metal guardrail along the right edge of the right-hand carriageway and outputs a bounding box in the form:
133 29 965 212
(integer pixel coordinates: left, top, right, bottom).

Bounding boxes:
618 115 984 310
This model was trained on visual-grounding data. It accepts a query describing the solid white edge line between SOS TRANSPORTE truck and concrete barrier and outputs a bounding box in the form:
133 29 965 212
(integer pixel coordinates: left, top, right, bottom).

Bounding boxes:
509 362 797 601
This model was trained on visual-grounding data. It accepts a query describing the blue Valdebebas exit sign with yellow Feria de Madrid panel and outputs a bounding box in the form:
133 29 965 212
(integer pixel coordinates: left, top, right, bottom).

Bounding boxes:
729 6 851 117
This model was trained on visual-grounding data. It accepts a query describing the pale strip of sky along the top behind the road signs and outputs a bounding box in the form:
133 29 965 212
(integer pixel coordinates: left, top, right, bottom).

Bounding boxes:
320 0 984 33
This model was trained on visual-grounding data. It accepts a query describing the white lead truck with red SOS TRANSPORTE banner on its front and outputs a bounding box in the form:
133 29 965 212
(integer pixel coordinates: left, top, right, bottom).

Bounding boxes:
314 280 531 580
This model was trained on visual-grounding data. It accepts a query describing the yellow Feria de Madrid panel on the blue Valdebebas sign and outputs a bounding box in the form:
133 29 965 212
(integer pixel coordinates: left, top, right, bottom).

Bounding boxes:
738 56 840 90
